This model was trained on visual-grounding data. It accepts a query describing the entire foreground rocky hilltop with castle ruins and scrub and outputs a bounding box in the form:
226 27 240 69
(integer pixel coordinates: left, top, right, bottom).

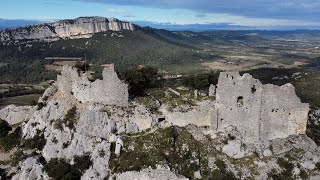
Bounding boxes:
0 65 320 180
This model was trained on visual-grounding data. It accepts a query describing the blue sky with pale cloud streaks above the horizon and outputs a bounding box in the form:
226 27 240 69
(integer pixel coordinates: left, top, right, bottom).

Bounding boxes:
0 0 320 29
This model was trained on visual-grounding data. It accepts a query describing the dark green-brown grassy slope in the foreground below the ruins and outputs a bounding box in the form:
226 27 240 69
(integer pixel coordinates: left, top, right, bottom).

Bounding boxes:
109 127 234 179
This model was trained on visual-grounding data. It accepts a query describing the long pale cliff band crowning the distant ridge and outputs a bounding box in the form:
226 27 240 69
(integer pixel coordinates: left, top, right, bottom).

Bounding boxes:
0 17 138 42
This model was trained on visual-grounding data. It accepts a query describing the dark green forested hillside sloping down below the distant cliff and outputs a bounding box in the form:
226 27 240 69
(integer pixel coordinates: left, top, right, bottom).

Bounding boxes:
0 29 217 83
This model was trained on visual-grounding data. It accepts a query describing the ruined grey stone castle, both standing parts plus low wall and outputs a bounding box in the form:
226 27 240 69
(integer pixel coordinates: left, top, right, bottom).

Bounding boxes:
57 65 309 144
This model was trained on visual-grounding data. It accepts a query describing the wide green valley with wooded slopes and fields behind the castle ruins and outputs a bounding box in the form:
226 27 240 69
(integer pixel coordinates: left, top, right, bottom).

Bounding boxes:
0 27 320 108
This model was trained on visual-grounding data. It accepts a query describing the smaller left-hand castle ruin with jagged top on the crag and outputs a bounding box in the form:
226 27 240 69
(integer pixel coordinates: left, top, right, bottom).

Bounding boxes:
57 64 128 106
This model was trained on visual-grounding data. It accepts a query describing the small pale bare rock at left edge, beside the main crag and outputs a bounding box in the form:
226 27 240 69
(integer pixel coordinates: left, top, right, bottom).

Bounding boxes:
0 105 36 125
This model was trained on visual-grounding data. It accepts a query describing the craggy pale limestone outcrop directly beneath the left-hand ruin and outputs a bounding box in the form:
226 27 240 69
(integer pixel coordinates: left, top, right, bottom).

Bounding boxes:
20 75 154 179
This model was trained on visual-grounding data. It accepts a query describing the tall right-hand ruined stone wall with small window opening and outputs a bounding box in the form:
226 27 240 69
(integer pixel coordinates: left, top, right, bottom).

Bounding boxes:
211 72 309 143
